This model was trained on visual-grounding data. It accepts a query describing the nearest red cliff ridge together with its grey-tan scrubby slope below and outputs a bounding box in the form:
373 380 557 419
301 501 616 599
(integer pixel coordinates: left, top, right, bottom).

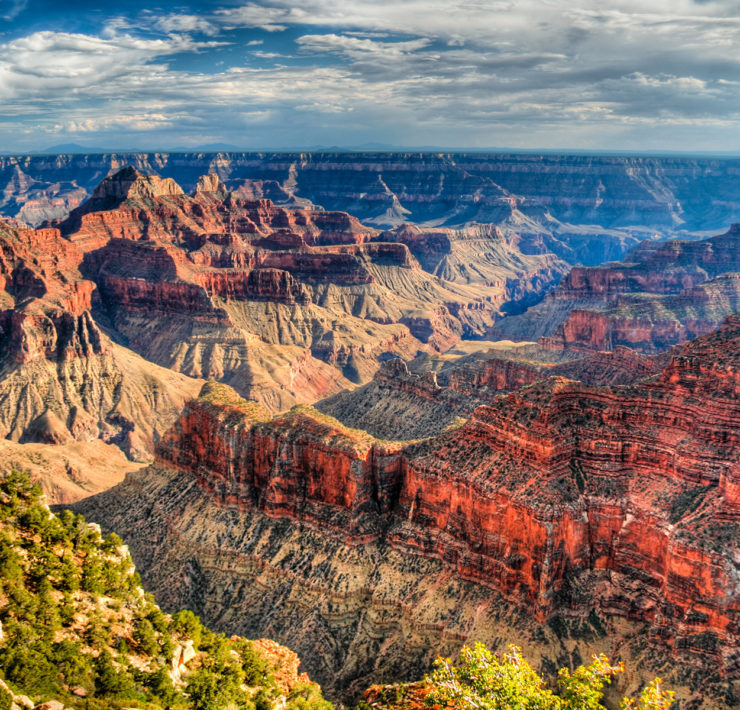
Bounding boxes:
75 316 740 707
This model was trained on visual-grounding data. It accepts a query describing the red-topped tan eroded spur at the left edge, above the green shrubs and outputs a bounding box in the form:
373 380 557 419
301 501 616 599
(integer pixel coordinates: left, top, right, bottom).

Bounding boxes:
0 224 201 470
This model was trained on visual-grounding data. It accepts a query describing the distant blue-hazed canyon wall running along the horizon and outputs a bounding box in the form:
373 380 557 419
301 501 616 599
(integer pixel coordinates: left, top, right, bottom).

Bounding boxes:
7 153 740 265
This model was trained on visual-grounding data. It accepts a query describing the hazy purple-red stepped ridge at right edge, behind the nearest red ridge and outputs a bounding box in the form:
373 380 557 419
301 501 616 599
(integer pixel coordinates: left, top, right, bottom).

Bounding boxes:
495 225 740 353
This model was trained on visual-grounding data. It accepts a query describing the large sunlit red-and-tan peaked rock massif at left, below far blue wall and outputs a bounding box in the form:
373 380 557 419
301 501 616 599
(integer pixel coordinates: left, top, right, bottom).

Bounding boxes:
0 167 565 495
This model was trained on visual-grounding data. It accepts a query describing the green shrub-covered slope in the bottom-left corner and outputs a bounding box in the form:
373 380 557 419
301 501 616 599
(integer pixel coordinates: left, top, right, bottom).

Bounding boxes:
0 473 331 710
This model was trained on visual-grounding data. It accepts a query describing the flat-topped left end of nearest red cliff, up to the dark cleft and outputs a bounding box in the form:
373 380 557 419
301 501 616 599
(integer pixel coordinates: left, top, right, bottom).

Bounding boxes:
157 383 408 541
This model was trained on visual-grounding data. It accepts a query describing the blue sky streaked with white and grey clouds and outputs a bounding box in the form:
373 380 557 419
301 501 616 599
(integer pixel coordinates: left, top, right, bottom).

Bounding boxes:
0 0 740 152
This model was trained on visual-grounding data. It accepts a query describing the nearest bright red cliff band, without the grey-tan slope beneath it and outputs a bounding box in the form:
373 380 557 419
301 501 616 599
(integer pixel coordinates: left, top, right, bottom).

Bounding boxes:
158 316 740 673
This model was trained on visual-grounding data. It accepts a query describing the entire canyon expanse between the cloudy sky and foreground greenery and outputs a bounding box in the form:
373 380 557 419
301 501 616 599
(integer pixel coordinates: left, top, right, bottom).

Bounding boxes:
0 147 740 709
